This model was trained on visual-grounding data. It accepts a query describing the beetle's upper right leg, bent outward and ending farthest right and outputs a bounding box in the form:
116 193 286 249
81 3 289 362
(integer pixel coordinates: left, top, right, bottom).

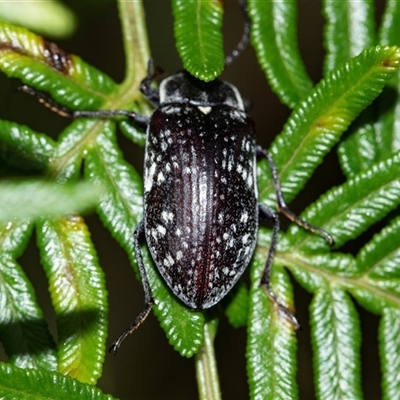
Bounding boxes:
257 146 335 248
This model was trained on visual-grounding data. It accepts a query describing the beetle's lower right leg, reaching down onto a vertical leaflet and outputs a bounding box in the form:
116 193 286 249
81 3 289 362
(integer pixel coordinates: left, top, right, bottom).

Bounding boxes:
258 204 300 331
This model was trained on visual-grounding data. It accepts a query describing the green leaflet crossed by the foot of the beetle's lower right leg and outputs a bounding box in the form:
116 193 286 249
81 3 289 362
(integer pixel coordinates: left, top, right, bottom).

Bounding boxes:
246 251 297 400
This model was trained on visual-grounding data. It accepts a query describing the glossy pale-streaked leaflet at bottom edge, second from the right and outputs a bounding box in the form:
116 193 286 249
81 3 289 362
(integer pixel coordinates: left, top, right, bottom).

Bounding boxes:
310 282 362 400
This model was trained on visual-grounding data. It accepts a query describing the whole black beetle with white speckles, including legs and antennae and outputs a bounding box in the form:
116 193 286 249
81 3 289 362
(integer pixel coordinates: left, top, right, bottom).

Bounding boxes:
22 0 334 353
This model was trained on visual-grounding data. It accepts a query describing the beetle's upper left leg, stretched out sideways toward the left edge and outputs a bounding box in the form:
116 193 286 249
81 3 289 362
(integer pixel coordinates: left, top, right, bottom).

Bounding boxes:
18 85 150 128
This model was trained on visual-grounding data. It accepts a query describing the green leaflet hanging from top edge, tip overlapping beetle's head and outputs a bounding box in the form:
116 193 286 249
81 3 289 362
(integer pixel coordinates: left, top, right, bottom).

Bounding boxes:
172 0 224 82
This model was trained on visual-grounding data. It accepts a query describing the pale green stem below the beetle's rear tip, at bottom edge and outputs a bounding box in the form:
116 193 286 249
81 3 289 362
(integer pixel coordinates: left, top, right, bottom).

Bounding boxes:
195 320 221 400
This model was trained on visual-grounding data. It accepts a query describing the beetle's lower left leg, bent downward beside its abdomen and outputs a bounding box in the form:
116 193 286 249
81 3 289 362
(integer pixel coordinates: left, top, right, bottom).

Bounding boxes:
109 220 154 354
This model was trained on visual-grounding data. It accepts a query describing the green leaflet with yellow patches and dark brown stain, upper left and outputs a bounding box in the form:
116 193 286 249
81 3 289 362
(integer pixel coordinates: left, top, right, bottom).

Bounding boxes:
0 22 117 109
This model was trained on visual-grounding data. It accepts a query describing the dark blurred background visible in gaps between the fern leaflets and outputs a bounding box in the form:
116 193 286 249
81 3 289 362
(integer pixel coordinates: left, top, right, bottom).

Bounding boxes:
0 0 383 400
